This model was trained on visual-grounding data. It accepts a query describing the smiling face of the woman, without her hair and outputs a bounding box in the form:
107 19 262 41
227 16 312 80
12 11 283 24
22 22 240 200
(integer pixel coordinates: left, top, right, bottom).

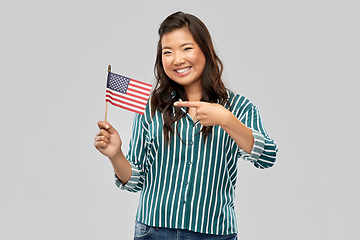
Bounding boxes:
161 28 206 90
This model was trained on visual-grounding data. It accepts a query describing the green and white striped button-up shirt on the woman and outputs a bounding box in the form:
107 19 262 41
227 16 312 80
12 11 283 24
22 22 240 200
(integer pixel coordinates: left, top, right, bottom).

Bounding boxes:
115 91 277 235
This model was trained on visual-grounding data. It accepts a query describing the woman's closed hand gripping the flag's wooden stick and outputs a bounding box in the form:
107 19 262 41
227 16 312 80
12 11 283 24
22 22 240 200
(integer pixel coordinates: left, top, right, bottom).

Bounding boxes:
94 121 122 159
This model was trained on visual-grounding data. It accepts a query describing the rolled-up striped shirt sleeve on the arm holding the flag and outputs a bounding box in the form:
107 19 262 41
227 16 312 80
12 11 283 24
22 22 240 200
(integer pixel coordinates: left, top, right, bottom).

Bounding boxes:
115 108 147 192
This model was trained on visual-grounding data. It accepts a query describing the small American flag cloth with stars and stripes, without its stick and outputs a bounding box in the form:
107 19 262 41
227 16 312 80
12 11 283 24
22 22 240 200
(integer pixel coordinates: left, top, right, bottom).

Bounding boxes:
106 72 152 115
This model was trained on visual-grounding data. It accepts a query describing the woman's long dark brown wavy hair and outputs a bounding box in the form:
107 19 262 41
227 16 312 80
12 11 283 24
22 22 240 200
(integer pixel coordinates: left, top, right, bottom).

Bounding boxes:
151 12 227 143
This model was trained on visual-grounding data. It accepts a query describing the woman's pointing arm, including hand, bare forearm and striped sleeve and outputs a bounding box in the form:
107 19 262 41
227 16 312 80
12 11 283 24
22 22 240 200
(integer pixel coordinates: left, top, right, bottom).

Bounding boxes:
174 101 277 168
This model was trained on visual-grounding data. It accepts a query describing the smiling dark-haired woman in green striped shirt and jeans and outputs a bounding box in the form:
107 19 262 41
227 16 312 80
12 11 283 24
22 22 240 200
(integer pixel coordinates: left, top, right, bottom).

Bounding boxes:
95 12 277 239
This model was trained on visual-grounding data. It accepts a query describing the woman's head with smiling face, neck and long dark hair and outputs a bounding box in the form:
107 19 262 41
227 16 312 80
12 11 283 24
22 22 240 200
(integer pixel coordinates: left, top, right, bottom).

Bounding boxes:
151 12 228 141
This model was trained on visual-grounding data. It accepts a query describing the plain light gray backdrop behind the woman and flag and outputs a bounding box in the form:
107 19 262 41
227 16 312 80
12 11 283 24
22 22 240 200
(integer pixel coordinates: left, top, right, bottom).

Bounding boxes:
0 0 360 240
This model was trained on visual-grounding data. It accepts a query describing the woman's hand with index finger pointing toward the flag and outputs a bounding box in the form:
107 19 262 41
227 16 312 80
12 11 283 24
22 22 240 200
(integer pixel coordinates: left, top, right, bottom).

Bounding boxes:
174 101 232 126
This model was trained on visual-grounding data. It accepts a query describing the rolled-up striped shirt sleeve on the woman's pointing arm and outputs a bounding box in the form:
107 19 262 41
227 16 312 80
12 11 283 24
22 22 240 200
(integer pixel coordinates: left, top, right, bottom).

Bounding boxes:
238 104 278 169
